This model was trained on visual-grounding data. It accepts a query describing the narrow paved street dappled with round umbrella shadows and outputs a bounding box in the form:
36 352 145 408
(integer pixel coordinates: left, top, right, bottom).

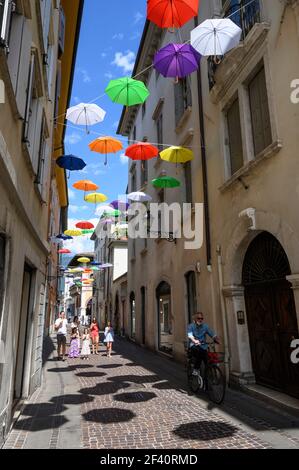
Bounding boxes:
3 338 299 449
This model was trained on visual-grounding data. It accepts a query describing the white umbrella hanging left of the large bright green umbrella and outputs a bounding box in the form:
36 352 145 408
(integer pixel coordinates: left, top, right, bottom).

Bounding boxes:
66 103 106 133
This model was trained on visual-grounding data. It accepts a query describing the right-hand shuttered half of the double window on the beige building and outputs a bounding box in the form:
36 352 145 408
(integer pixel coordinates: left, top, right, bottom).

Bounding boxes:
248 67 272 155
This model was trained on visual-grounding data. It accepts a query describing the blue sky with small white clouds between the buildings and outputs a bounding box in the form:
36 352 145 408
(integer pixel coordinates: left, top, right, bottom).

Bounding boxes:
64 0 146 253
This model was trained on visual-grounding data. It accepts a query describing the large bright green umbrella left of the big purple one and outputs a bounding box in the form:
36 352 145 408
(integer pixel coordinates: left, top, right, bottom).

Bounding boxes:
105 77 150 106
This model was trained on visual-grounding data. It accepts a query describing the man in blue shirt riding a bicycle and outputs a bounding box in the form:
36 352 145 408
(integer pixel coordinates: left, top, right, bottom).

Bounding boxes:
187 312 220 375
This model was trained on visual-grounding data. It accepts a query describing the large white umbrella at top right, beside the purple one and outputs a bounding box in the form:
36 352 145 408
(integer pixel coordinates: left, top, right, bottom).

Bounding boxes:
191 18 242 56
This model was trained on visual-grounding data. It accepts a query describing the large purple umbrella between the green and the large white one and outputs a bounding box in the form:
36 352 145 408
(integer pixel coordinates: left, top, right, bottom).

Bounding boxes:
154 44 201 78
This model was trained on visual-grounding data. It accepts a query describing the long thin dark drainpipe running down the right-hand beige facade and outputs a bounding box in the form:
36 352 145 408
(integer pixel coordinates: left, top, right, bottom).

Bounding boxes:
194 17 212 272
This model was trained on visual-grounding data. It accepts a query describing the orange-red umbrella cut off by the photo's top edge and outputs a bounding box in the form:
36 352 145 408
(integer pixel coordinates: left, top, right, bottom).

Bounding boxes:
147 0 199 28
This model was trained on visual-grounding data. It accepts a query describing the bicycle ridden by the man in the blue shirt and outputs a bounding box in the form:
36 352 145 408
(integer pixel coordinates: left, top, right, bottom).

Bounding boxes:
185 341 226 405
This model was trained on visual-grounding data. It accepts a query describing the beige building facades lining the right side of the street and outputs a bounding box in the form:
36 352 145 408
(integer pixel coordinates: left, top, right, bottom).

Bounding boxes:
118 0 299 396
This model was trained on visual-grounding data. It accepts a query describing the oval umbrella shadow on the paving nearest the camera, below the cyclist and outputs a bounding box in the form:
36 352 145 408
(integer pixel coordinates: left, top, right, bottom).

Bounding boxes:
172 421 238 441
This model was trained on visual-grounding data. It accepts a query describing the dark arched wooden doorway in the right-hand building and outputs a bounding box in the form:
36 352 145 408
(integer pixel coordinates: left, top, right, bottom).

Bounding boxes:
243 232 299 397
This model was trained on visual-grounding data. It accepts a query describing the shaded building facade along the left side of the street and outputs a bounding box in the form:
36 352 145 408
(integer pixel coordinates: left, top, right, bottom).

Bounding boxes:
0 0 82 443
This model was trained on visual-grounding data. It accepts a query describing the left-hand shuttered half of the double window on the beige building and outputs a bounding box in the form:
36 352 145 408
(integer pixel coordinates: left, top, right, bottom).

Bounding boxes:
226 99 243 175
